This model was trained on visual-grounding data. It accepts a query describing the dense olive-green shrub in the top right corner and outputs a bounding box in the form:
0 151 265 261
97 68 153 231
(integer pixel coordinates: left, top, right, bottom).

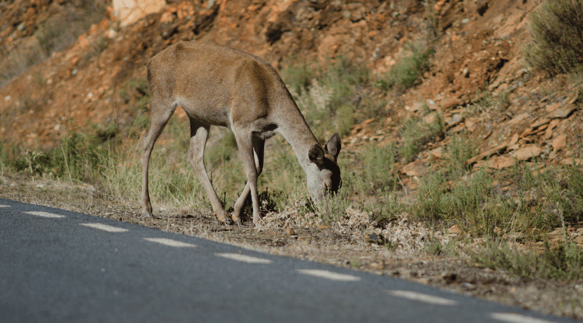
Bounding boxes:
524 0 583 75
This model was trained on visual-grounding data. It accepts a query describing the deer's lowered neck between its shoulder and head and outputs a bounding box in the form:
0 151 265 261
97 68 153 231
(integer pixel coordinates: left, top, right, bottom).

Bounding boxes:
278 101 319 172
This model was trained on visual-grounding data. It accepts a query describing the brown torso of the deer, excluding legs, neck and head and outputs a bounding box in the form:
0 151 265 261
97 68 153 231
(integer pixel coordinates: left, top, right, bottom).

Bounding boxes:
148 42 289 126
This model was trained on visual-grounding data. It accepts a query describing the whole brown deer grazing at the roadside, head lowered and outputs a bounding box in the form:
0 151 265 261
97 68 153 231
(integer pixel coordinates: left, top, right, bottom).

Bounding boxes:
141 42 342 227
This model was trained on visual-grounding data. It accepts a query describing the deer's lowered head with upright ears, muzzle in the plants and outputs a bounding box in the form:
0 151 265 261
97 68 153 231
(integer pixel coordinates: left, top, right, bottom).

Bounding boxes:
306 133 342 205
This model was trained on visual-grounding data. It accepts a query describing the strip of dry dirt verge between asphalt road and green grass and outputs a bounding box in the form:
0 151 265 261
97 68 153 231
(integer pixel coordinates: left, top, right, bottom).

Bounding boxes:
0 176 583 319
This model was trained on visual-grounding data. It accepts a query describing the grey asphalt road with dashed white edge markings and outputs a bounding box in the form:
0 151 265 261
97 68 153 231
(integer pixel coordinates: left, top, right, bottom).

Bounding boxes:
0 199 573 323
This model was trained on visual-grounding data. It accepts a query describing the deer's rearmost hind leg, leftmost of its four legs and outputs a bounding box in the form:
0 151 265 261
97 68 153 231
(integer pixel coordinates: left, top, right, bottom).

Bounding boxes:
141 99 176 217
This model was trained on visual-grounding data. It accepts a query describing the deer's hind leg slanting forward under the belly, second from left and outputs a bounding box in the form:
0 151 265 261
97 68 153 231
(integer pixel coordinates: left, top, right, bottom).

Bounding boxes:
188 118 229 223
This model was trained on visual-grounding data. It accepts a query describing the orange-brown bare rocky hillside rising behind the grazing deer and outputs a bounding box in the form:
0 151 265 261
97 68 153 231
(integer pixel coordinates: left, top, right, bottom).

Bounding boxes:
0 0 581 171
